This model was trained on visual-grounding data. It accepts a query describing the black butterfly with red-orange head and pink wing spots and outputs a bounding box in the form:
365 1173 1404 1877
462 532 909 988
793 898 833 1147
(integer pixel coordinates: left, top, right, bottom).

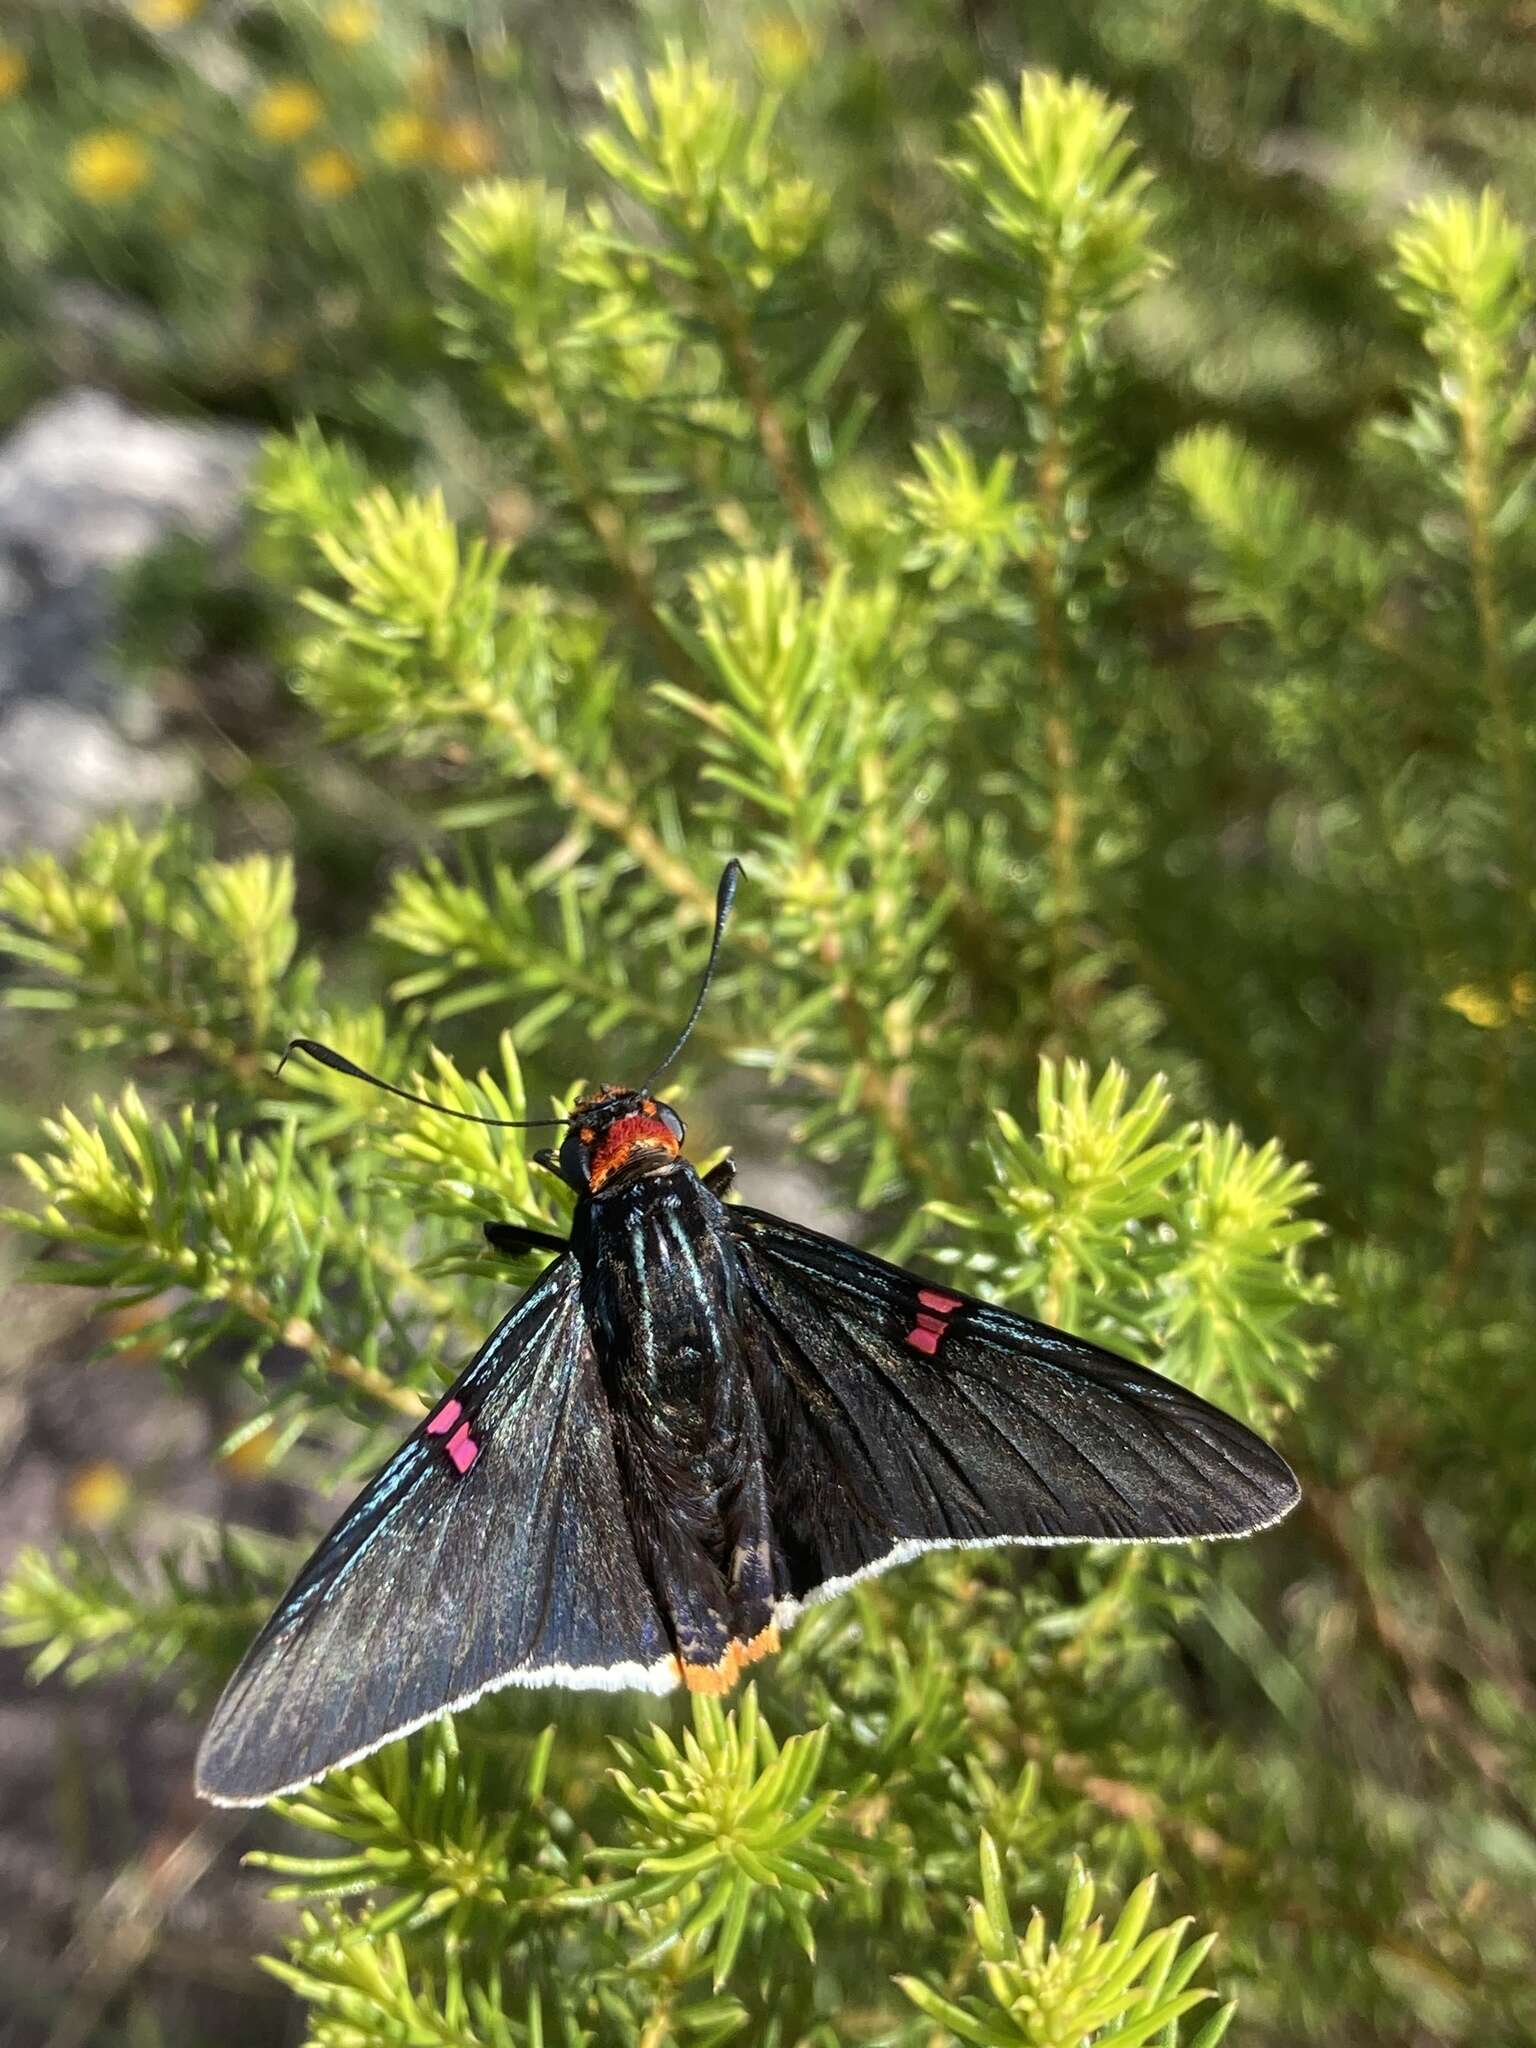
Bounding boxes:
197 862 1298 1806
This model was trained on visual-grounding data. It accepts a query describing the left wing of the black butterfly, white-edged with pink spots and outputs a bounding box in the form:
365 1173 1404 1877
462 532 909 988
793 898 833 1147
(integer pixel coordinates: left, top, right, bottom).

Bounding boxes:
197 1255 674 1804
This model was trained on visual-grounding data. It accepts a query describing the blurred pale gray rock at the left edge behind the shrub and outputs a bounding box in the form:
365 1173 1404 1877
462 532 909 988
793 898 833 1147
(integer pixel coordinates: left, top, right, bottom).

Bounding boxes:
0 391 258 854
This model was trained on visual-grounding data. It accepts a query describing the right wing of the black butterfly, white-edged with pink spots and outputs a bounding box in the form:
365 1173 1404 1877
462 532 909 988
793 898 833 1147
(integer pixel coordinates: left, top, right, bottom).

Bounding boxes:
729 1206 1296 1606
